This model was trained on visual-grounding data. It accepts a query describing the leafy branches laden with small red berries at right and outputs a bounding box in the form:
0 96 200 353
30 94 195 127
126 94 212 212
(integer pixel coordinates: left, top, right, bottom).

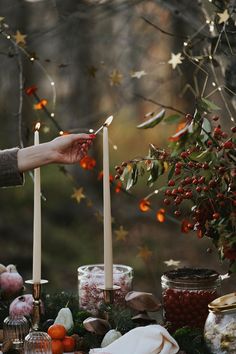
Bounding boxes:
115 114 236 261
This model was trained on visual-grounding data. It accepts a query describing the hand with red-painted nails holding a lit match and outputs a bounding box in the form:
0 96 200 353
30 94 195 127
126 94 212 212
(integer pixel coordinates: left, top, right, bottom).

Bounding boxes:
48 134 95 164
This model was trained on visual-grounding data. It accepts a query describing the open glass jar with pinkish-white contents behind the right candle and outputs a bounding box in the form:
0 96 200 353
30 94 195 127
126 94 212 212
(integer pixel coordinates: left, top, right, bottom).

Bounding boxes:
78 264 133 315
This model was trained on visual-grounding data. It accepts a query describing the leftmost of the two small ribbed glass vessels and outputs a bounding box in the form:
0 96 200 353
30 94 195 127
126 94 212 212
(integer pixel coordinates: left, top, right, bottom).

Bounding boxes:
3 316 29 350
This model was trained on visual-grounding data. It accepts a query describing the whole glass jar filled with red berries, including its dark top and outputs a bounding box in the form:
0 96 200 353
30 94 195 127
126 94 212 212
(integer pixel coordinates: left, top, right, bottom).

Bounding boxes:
161 268 220 332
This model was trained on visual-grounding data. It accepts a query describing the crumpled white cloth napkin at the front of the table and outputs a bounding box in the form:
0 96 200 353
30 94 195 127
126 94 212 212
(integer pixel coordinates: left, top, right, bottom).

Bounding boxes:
89 325 179 354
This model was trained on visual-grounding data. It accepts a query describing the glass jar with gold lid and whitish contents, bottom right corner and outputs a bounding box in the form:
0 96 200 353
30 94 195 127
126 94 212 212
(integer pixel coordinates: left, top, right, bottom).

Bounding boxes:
204 293 236 354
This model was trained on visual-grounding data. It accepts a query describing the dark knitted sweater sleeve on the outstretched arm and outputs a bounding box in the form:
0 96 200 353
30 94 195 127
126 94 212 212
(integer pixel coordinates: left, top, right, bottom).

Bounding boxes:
0 148 24 187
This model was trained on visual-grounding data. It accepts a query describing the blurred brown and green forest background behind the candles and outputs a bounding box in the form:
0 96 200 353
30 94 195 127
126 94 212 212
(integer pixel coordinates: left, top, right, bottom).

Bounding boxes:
0 0 235 296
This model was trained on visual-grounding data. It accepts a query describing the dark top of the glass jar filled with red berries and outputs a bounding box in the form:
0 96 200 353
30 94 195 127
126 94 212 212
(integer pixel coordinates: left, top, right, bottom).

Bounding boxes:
161 268 221 290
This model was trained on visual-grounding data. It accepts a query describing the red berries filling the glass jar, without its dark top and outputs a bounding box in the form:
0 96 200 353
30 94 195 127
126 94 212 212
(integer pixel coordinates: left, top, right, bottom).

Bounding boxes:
163 288 218 332
